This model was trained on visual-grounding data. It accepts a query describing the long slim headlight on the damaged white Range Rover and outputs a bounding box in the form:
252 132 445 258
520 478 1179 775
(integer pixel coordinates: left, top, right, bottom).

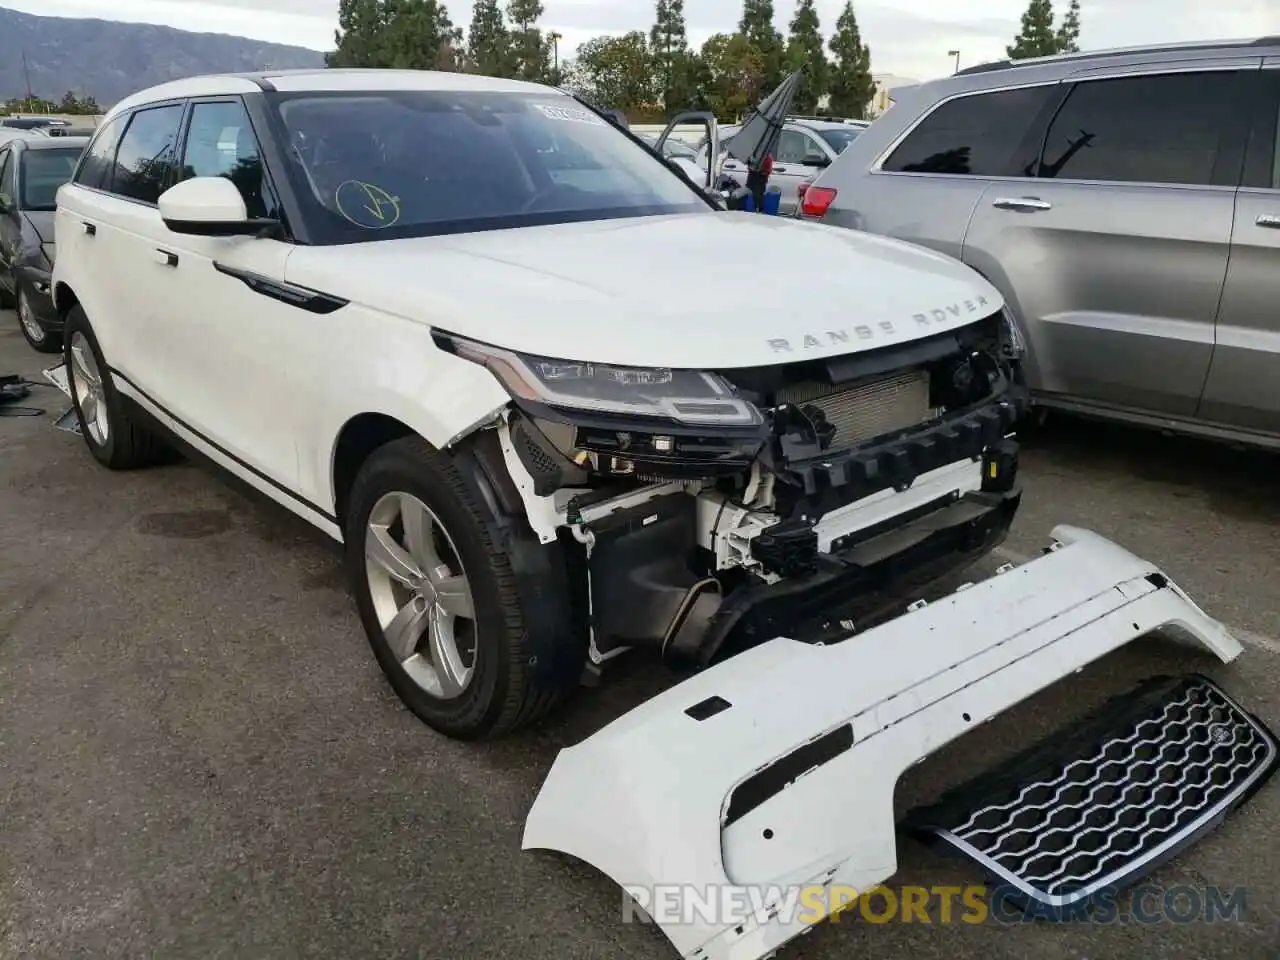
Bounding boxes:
449 337 763 426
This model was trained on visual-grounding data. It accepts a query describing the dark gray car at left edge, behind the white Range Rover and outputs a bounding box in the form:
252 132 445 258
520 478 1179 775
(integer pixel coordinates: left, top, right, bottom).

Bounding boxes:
0 137 88 353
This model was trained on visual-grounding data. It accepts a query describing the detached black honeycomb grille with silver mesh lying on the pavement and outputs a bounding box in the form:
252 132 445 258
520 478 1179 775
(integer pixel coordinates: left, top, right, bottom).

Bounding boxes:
916 677 1276 905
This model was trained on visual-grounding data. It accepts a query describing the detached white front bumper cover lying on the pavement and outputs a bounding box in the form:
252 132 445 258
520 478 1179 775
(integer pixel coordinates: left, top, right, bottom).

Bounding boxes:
524 526 1242 960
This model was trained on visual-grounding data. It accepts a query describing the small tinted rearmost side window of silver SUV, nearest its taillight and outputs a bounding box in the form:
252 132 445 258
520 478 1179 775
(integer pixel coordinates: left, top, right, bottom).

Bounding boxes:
881 84 1060 177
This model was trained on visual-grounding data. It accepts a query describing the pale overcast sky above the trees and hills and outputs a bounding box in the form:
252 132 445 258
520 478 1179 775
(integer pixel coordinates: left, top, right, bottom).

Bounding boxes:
10 0 1280 79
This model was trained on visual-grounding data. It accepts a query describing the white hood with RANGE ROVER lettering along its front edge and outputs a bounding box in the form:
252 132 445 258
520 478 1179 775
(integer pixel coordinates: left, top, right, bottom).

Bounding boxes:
287 212 1002 367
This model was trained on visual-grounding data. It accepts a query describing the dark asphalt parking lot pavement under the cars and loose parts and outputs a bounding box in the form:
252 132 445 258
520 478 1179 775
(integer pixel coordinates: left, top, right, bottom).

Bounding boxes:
0 314 1280 960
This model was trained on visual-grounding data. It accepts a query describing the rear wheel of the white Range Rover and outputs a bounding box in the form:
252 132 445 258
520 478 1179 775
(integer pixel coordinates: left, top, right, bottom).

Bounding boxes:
63 305 164 470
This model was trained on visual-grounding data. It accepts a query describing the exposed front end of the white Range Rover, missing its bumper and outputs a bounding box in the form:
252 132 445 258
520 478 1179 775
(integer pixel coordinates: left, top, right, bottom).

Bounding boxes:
483 314 1025 666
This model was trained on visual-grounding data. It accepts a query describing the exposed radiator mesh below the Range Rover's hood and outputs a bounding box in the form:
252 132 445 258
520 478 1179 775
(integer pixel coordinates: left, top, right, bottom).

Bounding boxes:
777 370 940 449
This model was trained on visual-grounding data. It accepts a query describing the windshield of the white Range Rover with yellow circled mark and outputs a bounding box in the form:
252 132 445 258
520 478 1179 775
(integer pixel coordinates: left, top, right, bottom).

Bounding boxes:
274 91 713 243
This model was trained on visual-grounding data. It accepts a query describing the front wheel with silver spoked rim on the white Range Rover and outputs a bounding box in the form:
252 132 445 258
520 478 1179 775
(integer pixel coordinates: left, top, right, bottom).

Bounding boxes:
343 436 576 740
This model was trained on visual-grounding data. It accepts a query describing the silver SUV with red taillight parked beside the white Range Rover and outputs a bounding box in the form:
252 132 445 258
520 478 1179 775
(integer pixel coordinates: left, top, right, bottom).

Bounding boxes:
800 37 1280 447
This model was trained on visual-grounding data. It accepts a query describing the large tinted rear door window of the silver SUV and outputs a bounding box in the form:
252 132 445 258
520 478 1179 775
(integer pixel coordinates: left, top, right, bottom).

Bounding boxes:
1039 70 1240 186
